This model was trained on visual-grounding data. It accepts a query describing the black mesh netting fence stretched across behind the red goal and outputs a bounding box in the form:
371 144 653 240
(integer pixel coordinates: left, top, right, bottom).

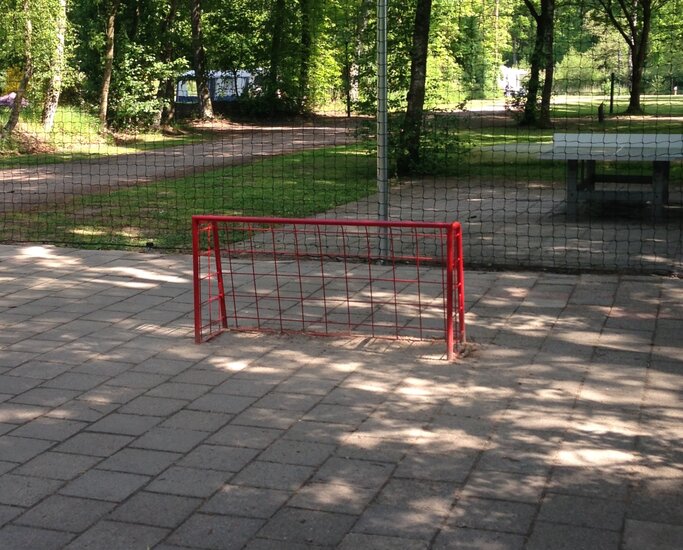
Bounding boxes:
0 0 683 274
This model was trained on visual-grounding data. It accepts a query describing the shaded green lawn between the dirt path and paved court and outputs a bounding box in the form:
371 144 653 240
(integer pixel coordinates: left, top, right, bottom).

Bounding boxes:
0 145 376 250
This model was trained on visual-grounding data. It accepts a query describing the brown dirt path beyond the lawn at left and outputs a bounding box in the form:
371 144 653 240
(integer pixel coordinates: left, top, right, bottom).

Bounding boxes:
0 120 353 212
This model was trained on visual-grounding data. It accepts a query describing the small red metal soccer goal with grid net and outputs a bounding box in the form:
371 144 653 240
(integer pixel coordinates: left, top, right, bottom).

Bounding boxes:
192 216 465 360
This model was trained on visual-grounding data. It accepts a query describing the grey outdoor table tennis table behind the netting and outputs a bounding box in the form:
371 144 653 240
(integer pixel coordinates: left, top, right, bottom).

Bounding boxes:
541 133 683 216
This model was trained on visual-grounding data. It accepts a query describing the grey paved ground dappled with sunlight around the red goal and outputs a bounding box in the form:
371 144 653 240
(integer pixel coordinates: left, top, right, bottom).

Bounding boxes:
0 246 683 550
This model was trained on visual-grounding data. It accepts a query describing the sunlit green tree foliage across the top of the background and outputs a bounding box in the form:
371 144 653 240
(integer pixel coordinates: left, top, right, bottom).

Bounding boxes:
0 0 683 133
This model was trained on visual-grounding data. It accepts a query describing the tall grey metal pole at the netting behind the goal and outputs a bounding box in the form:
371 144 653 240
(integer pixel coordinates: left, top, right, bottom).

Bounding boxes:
377 0 389 258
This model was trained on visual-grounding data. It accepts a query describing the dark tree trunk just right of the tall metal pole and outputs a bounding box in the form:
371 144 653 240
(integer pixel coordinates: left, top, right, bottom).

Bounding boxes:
397 0 432 175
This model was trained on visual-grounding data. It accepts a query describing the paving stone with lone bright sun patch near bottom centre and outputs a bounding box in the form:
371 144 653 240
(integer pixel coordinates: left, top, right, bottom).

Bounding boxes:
288 483 377 514
